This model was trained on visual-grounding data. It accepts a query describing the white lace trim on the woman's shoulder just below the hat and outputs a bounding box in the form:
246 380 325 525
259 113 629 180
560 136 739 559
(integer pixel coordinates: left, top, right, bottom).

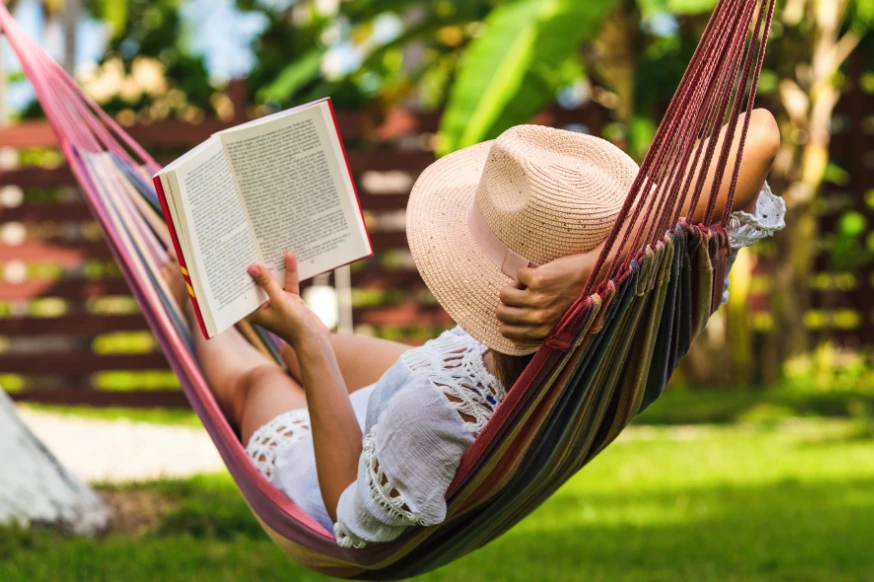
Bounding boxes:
401 328 507 436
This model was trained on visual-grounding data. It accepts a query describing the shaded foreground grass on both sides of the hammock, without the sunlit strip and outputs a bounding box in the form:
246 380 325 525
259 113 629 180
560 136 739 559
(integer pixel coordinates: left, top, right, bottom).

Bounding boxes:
0 479 874 582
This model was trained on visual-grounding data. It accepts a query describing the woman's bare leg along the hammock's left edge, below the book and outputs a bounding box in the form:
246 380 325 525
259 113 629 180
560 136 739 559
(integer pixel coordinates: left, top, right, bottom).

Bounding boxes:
161 260 306 444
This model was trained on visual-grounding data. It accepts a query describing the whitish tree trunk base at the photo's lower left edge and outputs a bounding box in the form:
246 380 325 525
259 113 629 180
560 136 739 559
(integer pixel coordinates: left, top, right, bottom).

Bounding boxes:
0 389 109 535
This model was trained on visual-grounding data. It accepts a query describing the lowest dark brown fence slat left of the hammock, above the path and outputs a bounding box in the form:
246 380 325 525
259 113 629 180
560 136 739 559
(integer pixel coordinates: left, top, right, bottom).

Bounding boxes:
10 387 189 408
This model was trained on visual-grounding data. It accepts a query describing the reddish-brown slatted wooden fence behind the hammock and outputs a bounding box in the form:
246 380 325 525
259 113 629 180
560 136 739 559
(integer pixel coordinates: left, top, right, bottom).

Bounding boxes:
0 86 603 406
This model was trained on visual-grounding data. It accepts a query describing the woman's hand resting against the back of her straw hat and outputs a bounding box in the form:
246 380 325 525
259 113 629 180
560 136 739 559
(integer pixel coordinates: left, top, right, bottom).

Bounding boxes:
497 246 601 342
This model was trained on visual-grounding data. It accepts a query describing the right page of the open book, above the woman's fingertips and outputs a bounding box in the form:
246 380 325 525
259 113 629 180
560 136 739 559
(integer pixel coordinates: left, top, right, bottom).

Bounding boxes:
218 102 370 279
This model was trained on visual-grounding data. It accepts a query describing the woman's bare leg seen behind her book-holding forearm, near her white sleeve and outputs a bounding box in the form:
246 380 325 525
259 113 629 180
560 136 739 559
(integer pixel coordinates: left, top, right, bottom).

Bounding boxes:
280 334 411 394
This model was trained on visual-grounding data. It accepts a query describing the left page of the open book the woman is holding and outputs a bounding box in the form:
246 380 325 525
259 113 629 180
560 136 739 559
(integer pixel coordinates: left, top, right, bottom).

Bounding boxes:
176 139 266 333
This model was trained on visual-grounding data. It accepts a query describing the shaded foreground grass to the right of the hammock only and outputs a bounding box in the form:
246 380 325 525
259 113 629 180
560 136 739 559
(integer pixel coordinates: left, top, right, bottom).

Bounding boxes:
426 480 874 581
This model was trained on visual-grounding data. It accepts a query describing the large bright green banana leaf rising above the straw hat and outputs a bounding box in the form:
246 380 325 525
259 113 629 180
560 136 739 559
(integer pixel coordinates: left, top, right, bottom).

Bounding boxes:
439 0 615 154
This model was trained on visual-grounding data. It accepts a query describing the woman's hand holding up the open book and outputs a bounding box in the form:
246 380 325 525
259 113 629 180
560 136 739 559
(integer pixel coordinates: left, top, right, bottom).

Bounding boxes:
248 253 328 347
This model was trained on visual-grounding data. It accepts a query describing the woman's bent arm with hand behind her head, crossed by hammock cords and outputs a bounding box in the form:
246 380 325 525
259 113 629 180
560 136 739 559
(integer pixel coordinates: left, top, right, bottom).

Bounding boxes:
497 109 780 341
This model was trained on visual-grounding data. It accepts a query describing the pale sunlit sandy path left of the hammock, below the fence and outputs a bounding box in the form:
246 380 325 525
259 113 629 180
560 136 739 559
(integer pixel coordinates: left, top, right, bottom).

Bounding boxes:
19 407 224 483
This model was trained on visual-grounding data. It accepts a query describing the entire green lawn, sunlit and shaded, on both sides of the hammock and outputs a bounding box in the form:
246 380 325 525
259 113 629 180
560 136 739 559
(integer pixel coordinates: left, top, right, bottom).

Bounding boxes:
0 419 874 582
